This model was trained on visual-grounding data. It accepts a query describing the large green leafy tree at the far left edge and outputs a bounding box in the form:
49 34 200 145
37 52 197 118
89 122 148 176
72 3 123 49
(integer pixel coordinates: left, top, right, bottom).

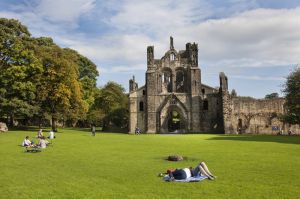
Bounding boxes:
0 18 43 125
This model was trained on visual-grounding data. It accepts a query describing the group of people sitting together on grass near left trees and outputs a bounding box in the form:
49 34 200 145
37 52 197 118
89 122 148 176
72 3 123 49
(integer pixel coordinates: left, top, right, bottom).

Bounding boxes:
22 129 55 149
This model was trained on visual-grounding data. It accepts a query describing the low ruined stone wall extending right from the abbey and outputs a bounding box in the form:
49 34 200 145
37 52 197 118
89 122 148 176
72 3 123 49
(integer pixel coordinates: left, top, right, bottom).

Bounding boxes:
223 95 300 134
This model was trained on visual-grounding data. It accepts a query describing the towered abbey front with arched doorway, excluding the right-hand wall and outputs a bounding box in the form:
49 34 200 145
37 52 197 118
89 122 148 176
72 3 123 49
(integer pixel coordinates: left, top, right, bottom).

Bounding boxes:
129 37 221 133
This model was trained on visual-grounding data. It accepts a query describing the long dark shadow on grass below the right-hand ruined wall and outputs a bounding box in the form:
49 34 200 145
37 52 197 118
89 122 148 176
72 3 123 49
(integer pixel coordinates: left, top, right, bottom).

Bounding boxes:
207 135 300 144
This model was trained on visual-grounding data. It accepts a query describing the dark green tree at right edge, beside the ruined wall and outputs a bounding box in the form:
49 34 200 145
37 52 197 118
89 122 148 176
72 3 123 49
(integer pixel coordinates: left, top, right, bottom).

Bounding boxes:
283 67 300 124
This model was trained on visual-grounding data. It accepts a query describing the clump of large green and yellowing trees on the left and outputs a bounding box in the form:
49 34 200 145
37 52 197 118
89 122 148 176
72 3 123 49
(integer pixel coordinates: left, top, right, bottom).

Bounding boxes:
0 18 99 130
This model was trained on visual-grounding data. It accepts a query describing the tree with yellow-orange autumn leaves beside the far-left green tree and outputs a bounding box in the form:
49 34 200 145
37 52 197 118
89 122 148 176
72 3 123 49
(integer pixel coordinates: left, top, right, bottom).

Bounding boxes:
36 38 87 131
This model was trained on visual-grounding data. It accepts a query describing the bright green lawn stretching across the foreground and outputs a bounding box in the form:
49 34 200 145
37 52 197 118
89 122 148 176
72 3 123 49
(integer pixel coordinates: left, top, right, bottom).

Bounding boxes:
0 129 300 199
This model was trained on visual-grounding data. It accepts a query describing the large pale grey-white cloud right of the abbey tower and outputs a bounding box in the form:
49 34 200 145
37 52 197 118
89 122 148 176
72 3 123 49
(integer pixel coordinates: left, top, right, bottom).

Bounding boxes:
195 8 300 65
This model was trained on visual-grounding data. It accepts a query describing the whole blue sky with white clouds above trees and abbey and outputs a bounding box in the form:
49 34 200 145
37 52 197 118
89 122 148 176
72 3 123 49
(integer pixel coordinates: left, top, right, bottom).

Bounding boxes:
0 0 300 98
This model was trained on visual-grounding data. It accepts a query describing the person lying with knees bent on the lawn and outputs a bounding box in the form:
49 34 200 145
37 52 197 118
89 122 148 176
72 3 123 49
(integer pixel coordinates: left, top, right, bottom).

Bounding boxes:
167 162 216 180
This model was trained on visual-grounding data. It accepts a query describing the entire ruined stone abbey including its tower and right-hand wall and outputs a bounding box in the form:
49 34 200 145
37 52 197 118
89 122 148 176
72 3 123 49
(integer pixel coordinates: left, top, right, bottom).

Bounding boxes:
129 37 300 134
